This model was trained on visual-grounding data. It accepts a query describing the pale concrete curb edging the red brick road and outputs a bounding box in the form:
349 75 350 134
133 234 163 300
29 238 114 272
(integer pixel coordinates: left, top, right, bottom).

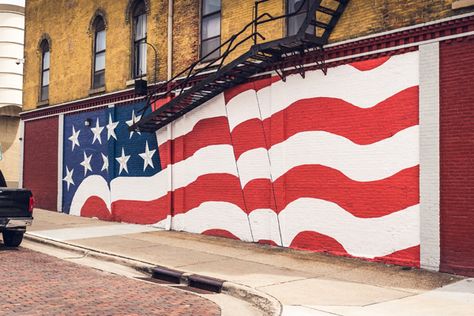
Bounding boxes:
24 232 282 316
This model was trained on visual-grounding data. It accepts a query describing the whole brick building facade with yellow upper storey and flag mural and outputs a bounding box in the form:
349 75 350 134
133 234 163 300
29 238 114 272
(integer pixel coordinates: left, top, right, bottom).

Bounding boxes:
21 0 474 275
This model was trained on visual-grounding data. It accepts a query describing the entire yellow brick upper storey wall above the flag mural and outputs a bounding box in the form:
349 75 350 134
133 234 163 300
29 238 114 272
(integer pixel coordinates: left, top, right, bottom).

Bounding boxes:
24 0 472 110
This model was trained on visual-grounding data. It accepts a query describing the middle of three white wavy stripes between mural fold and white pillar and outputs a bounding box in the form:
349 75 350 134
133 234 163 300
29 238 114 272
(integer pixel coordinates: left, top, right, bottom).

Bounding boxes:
268 126 419 181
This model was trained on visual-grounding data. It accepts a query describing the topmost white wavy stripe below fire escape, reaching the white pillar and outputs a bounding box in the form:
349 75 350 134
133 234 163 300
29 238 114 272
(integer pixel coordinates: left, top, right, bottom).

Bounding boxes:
263 52 418 119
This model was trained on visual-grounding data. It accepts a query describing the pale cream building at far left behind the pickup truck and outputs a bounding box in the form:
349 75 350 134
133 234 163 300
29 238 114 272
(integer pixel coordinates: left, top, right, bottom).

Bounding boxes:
0 1 25 187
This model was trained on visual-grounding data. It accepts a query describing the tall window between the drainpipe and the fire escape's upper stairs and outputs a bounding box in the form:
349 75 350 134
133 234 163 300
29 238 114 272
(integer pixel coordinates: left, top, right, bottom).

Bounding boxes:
201 0 221 60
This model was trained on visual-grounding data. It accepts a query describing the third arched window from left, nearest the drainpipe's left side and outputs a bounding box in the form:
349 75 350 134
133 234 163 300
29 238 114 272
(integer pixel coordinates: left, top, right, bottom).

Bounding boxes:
132 1 147 78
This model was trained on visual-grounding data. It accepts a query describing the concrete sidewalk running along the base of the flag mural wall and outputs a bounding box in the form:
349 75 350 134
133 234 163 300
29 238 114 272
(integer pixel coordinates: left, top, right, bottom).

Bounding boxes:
26 209 474 316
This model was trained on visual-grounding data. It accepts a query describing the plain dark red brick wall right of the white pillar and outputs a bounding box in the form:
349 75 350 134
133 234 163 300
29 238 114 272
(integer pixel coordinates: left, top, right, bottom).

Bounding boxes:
440 37 474 276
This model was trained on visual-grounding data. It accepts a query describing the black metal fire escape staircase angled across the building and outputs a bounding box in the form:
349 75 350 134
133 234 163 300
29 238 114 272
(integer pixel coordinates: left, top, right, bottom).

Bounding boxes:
130 0 350 132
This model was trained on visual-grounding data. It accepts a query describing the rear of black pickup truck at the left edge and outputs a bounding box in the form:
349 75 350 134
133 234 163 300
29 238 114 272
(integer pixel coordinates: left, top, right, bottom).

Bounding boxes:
0 170 34 247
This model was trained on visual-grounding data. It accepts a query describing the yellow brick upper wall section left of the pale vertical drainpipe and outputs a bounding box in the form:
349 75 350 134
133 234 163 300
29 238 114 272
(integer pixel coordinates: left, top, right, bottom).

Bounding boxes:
23 0 168 110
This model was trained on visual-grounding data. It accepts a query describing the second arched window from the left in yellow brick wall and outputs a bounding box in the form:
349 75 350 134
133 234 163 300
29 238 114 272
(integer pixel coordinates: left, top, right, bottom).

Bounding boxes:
92 16 106 89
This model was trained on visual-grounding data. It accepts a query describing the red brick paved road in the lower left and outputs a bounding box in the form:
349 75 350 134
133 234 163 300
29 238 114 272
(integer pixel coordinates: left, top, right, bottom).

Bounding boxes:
0 246 220 315
